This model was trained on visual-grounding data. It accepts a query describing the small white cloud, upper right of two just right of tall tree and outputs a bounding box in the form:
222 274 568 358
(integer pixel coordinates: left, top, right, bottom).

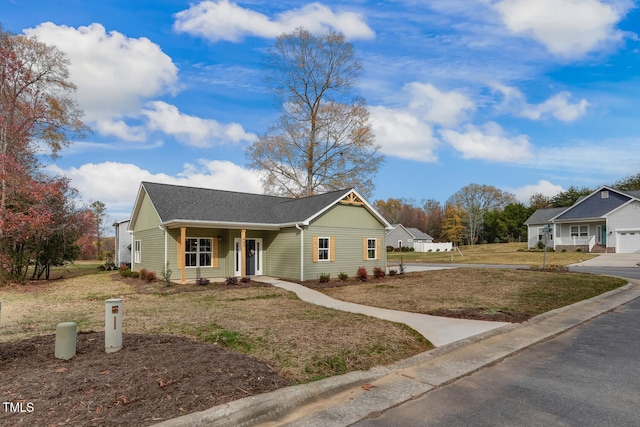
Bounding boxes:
404 82 476 126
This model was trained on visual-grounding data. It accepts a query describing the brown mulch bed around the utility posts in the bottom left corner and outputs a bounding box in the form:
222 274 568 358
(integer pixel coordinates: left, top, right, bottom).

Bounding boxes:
0 332 289 426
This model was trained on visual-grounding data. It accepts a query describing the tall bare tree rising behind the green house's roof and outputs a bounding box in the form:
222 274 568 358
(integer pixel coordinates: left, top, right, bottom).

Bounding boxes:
247 28 382 197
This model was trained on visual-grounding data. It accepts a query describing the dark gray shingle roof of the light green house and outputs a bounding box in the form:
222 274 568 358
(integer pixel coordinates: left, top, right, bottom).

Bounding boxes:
142 182 351 224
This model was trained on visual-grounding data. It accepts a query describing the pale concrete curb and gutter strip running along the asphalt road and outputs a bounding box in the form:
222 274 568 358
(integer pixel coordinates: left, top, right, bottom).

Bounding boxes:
157 281 640 427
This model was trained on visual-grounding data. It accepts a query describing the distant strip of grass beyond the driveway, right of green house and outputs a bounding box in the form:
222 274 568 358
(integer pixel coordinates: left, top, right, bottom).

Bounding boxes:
387 243 597 266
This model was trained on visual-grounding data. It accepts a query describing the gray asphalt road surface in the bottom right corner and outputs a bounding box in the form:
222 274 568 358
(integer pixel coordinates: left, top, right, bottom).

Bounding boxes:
355 296 640 427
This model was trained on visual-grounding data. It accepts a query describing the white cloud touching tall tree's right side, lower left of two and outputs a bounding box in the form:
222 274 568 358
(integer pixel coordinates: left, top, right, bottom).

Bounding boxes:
368 106 438 162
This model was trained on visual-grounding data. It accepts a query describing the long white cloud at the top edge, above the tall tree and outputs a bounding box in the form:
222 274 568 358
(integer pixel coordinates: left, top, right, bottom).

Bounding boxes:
174 0 375 42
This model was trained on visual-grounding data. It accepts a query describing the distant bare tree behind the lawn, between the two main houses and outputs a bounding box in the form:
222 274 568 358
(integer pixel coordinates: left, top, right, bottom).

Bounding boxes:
449 184 516 245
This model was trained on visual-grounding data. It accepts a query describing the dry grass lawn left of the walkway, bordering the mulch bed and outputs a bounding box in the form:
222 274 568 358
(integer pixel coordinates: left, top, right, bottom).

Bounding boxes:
0 273 432 382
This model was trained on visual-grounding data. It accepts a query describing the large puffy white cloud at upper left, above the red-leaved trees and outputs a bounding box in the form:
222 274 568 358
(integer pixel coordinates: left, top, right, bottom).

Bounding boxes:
24 22 178 123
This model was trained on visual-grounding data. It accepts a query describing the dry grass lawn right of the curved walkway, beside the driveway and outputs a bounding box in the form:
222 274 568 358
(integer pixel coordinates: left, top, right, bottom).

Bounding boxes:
323 268 626 315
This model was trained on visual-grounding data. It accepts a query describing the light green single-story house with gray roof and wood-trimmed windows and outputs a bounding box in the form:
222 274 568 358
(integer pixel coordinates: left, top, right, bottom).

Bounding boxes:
129 182 390 283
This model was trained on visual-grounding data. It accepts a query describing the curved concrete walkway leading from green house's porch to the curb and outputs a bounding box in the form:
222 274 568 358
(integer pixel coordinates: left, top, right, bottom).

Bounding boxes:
260 276 509 347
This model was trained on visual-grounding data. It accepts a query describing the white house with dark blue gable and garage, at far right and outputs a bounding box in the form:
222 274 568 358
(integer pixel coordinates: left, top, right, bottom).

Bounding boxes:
525 186 640 254
